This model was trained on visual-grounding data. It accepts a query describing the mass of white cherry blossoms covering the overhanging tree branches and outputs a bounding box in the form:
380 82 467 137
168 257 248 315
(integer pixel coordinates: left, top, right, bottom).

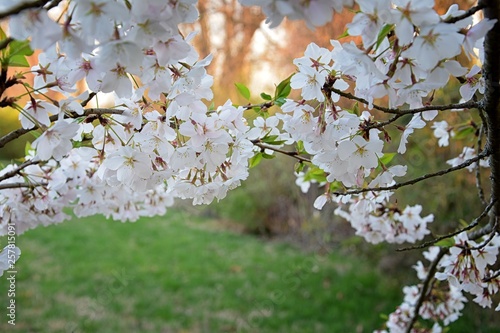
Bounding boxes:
0 0 500 332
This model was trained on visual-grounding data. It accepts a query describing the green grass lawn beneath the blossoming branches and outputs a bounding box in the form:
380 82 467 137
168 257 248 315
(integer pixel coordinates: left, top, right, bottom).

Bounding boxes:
0 210 498 333
